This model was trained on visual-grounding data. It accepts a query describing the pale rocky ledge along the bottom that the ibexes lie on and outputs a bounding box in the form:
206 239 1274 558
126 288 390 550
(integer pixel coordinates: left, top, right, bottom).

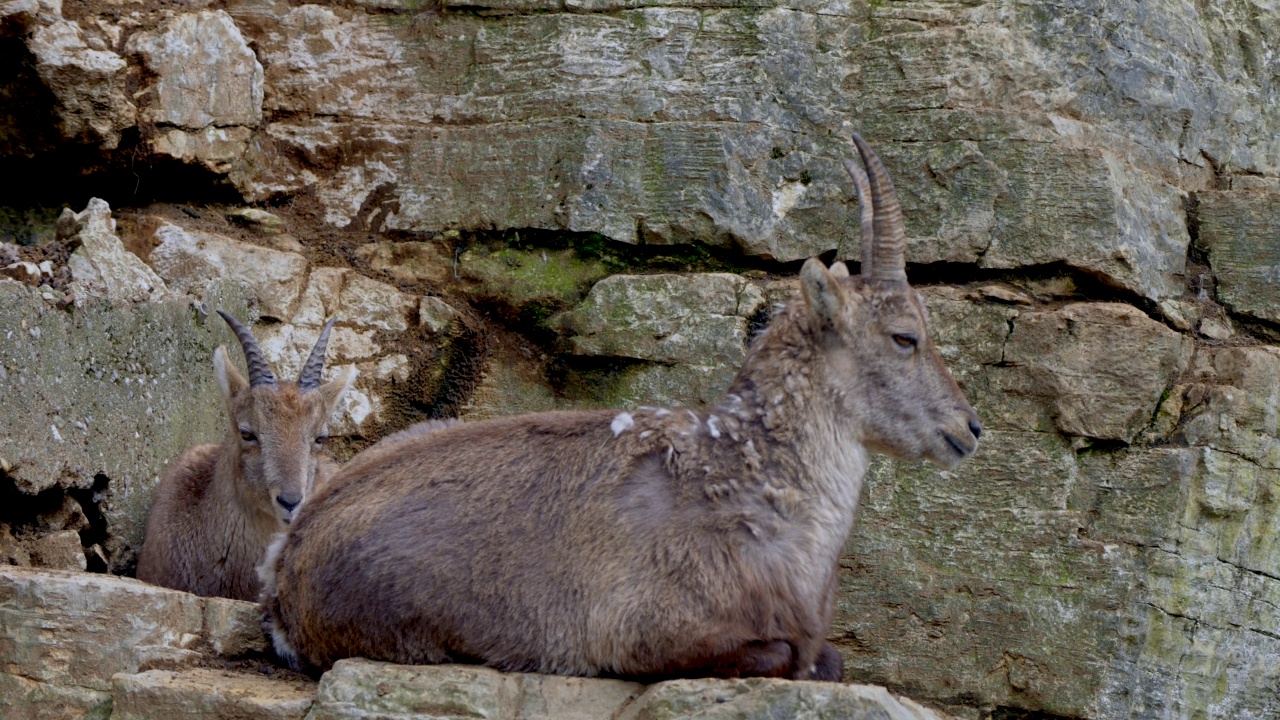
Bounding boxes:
0 568 947 720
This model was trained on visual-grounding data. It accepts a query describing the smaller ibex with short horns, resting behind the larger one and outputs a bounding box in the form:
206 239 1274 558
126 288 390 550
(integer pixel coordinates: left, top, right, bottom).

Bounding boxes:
137 310 355 600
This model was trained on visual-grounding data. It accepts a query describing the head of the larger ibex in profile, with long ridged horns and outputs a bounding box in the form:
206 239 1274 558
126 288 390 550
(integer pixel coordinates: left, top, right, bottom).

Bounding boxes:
800 135 982 468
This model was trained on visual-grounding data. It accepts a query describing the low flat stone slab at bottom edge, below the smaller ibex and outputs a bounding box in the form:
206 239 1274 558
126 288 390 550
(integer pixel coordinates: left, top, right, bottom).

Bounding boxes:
111 667 315 720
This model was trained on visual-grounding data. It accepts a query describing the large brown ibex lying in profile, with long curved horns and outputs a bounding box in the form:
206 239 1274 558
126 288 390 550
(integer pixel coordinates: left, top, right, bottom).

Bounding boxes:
262 136 982 680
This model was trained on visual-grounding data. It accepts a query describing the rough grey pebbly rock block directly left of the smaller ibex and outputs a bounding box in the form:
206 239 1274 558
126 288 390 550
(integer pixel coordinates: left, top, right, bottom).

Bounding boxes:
0 279 244 568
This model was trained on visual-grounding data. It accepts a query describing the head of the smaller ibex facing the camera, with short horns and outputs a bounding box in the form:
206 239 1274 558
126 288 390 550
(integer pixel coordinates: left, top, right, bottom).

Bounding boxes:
214 310 356 523
